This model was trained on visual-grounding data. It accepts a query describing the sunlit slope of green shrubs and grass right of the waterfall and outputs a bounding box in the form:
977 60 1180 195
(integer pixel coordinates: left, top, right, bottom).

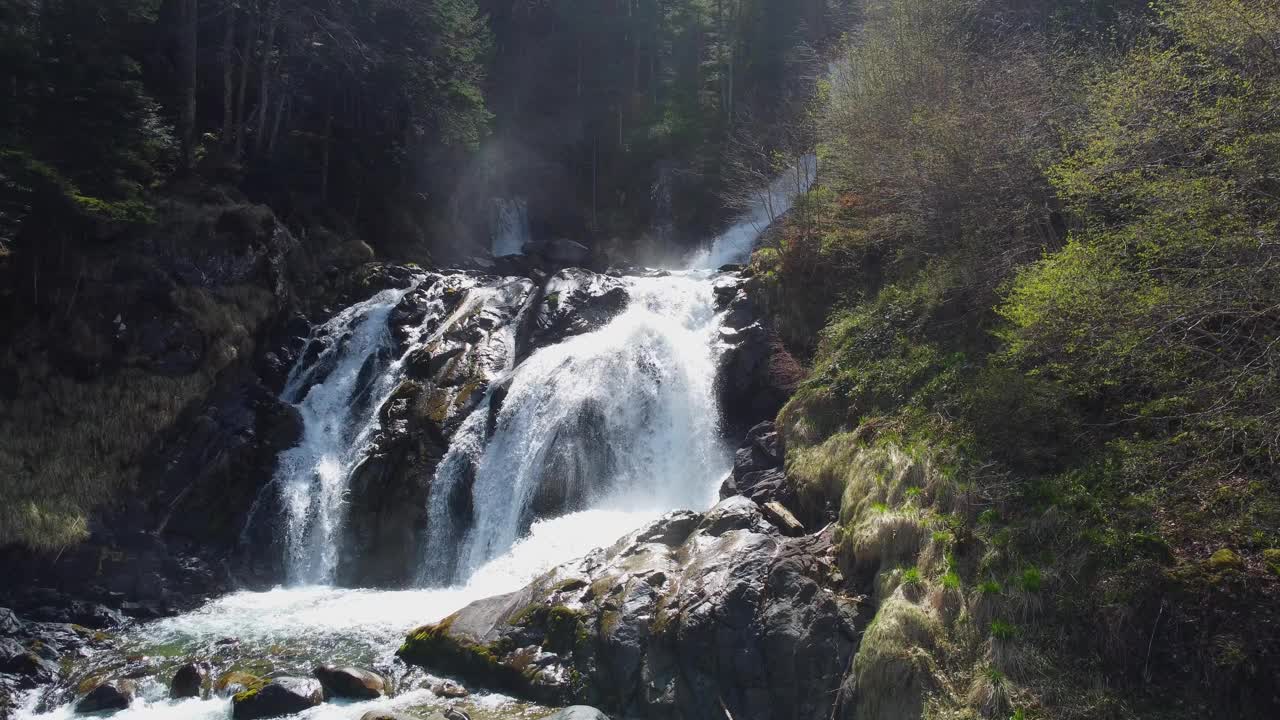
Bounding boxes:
754 0 1280 719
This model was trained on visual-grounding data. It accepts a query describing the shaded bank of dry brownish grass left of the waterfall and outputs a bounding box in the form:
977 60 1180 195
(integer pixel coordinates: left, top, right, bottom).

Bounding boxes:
0 281 279 551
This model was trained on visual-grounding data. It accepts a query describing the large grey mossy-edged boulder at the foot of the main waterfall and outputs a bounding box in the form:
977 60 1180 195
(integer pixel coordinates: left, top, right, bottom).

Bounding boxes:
399 497 858 720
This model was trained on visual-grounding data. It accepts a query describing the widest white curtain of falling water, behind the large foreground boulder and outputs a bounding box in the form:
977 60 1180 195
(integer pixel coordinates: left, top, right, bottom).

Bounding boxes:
424 274 728 583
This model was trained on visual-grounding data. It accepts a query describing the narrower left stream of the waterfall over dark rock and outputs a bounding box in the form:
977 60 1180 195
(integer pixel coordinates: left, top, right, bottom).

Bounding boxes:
270 274 527 585
